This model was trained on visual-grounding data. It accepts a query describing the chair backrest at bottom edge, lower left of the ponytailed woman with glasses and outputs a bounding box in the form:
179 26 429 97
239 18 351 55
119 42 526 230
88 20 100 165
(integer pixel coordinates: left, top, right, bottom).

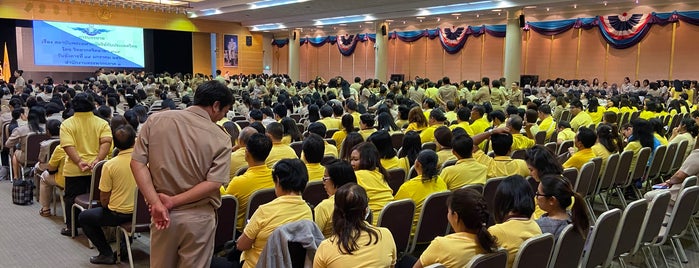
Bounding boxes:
512 233 554 268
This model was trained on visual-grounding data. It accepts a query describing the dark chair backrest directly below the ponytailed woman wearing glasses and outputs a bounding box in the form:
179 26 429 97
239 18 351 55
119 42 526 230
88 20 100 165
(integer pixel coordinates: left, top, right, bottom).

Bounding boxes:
548 224 585 268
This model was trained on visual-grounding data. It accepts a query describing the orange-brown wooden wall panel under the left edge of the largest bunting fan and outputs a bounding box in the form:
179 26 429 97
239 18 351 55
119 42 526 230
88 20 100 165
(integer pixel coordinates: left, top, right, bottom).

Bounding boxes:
578 28 607 84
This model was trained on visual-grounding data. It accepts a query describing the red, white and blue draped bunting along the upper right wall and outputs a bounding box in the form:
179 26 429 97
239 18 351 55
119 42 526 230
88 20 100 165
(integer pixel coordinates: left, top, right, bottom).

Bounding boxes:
272 11 699 53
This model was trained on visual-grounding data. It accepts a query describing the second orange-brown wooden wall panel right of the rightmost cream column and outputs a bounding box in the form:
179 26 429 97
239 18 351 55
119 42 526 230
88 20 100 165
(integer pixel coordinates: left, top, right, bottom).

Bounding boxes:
551 29 580 79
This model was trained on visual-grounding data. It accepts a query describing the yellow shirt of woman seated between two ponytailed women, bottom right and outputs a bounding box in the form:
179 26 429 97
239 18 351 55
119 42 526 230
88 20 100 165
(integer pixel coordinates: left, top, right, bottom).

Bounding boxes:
488 219 541 267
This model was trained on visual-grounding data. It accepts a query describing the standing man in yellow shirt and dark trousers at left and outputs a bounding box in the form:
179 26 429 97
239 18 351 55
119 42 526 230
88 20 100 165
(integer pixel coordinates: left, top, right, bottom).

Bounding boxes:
59 93 112 236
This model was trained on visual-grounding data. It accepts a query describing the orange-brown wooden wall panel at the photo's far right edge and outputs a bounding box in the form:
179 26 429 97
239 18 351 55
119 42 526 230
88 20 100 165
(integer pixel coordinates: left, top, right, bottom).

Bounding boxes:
672 21 699 80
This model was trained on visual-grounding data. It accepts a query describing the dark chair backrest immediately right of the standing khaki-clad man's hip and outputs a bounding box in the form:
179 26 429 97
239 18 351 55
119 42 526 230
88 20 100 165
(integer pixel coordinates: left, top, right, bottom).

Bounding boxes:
214 195 238 250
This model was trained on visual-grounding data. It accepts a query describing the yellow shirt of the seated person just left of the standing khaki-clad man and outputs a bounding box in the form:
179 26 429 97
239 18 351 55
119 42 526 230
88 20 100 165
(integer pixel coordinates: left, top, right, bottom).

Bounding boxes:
99 148 136 214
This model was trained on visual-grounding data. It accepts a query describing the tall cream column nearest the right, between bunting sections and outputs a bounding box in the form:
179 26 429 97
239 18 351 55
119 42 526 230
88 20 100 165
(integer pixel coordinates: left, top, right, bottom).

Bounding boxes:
503 10 522 88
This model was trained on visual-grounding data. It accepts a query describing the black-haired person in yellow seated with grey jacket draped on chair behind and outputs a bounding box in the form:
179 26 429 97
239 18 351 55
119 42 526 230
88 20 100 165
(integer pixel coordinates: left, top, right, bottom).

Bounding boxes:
236 159 313 268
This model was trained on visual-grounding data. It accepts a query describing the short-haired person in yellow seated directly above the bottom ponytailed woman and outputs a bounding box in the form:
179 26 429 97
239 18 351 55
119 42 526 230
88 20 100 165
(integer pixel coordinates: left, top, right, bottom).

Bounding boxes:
439 135 488 191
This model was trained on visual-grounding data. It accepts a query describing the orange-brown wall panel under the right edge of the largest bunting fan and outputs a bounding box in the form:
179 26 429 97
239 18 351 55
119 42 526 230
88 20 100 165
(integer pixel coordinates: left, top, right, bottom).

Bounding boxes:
640 25 672 81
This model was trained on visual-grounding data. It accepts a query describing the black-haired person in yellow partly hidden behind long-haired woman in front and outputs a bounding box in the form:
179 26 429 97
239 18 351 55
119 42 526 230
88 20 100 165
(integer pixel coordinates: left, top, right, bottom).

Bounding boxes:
313 159 357 238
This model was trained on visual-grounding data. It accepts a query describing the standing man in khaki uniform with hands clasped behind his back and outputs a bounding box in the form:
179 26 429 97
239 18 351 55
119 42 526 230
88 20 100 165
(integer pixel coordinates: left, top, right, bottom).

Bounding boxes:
129 81 233 267
